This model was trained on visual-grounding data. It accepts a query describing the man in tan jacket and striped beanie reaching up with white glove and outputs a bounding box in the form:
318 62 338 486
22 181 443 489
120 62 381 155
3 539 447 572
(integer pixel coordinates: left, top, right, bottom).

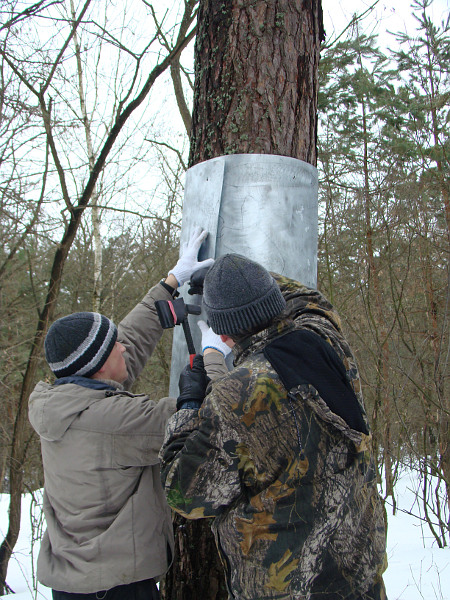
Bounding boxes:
29 229 213 600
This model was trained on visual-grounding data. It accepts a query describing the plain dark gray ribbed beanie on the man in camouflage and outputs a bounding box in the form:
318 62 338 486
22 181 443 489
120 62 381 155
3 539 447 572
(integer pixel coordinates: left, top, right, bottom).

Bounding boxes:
203 254 286 335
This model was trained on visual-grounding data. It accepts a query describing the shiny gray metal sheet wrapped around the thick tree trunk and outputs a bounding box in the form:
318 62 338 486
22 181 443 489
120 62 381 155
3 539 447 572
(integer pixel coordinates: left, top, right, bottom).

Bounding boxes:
170 154 318 396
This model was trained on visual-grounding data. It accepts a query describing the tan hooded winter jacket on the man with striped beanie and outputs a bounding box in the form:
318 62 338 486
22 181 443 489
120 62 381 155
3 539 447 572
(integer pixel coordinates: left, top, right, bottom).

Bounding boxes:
29 284 175 593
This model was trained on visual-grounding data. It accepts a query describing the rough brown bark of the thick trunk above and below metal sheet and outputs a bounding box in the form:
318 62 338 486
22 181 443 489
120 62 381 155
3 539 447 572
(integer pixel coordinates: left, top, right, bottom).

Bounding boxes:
162 0 324 600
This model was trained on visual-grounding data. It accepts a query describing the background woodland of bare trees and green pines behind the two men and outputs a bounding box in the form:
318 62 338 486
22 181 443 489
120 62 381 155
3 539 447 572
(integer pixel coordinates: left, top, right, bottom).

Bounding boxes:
0 0 450 586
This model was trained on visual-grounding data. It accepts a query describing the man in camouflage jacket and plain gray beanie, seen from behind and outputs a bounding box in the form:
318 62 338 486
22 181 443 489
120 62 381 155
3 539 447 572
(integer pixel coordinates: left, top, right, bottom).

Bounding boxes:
160 255 386 600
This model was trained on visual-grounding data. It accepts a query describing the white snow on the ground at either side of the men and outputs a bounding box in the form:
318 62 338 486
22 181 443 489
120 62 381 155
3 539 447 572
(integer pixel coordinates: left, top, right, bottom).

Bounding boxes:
0 472 450 600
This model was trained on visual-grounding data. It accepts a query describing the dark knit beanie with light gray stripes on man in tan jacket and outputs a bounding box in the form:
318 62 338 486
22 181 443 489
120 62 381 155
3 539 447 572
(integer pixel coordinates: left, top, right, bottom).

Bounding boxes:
44 312 117 377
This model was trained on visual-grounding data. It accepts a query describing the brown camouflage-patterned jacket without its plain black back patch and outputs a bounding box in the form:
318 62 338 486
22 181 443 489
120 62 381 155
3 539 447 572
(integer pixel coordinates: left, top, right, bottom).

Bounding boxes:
160 274 386 600
